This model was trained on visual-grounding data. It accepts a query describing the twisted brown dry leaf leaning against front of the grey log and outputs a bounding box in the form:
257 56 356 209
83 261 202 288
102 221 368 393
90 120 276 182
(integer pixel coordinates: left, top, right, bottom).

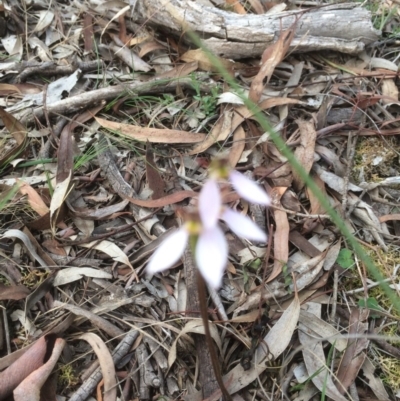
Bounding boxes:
249 21 297 104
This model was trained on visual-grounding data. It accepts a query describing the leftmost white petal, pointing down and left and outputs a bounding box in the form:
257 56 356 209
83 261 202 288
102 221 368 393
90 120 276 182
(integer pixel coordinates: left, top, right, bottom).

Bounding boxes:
146 227 189 274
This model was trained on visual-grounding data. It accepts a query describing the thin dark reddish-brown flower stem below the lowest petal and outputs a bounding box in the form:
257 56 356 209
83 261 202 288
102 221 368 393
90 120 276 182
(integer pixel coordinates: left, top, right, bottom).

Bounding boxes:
197 271 232 401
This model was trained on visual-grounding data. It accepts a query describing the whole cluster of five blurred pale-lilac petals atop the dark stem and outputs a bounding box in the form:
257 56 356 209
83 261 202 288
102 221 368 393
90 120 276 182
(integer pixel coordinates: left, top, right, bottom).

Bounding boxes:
147 172 269 288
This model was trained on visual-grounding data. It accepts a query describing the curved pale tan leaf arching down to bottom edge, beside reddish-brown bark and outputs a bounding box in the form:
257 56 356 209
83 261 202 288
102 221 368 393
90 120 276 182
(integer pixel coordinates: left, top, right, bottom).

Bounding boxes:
79 333 117 401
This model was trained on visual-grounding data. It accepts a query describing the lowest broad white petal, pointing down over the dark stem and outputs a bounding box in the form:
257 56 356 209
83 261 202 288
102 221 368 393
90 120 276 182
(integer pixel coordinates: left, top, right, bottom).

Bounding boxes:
195 226 228 289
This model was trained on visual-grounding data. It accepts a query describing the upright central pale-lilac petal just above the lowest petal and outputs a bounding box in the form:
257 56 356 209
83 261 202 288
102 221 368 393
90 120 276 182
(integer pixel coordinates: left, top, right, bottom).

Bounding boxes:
199 180 221 229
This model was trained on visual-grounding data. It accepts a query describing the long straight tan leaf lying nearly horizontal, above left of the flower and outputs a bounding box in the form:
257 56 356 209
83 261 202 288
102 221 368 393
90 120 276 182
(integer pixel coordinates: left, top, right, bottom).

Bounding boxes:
95 117 206 143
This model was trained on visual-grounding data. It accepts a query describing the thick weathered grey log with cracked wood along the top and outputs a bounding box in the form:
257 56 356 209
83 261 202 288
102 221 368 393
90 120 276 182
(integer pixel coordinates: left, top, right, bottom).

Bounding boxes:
133 0 379 59
